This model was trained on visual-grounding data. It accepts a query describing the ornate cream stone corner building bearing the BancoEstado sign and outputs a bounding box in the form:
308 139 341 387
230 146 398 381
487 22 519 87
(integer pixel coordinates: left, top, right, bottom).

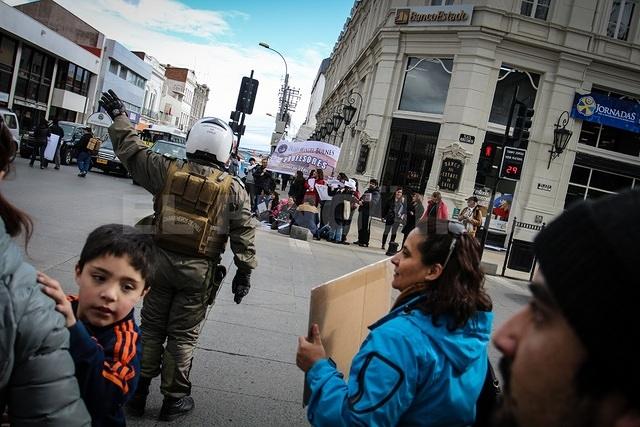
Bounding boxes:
316 0 640 246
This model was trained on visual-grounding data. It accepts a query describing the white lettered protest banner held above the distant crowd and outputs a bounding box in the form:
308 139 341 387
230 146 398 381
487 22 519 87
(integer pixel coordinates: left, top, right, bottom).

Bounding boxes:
267 140 340 177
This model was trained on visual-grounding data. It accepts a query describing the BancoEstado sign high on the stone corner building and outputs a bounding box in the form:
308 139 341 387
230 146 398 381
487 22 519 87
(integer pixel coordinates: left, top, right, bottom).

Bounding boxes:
394 4 473 27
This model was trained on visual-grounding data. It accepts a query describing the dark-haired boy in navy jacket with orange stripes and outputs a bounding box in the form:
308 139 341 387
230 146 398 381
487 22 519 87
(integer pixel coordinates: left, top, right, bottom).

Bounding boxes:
38 224 155 426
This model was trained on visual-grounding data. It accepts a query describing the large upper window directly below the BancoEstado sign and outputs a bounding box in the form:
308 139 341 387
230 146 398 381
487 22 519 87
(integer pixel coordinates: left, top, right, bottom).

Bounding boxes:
399 57 453 114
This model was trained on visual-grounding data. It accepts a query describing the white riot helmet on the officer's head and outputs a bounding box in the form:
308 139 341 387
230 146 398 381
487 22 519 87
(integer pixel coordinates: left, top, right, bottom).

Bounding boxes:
186 117 233 163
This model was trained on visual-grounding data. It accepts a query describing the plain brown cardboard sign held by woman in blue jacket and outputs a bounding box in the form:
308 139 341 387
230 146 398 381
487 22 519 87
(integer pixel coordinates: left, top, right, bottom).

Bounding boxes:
303 259 393 404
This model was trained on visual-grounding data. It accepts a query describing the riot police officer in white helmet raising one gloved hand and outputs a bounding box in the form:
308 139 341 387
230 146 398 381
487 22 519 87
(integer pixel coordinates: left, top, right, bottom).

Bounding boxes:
100 90 257 421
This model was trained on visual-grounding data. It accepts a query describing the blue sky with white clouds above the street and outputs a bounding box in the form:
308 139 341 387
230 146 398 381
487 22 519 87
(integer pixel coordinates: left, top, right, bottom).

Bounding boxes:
4 0 353 149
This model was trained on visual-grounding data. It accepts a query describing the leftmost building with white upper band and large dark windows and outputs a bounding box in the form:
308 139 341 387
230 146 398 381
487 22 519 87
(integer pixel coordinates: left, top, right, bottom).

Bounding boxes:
0 2 100 132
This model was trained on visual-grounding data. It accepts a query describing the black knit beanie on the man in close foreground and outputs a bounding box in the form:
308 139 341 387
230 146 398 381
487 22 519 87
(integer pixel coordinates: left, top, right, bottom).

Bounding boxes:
535 190 640 396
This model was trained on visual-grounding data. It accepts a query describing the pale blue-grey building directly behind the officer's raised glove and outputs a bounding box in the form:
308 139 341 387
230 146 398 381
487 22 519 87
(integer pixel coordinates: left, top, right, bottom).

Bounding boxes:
94 39 152 124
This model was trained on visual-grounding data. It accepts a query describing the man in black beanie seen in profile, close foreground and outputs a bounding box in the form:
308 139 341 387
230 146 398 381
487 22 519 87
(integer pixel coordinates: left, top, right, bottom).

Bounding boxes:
493 190 640 427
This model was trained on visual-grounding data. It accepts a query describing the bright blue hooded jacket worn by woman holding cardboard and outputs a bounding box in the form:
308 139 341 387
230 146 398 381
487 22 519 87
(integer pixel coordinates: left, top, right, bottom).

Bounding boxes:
307 297 493 427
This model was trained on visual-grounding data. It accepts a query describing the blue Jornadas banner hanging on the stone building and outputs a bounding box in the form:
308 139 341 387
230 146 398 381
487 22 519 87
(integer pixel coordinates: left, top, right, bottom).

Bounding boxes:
571 93 640 133
